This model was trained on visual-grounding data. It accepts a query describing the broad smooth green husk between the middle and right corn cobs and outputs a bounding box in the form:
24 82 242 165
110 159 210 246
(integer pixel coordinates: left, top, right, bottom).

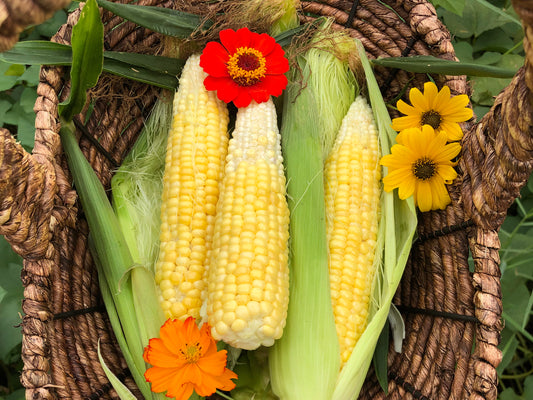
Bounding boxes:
269 25 355 400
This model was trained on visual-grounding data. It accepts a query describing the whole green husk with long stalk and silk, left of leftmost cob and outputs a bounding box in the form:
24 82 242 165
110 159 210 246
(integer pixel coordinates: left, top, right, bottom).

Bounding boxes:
61 97 172 399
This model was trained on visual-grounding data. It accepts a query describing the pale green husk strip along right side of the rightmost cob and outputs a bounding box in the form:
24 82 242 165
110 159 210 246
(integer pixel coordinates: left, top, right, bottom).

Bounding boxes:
331 41 417 400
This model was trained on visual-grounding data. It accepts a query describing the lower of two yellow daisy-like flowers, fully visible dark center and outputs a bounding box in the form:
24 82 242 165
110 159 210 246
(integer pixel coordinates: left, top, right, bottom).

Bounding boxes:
380 125 461 211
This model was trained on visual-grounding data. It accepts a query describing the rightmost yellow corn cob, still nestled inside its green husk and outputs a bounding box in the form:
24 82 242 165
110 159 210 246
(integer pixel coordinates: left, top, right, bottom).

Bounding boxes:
325 96 381 366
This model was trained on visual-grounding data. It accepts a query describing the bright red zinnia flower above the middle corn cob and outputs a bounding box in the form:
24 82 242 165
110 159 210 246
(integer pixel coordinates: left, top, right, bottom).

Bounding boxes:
200 28 289 107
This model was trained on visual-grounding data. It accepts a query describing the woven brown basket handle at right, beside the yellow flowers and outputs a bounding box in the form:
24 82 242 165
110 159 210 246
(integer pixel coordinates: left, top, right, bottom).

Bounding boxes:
460 0 533 230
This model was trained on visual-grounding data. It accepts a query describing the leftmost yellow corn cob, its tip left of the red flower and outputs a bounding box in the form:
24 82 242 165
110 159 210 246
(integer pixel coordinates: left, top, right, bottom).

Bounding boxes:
156 55 229 319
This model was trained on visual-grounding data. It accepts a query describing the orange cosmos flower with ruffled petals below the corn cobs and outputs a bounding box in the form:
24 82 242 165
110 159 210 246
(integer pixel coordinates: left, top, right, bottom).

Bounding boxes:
143 317 237 400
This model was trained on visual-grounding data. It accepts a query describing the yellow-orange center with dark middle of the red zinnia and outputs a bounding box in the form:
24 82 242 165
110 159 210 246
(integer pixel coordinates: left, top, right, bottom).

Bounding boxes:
227 47 266 86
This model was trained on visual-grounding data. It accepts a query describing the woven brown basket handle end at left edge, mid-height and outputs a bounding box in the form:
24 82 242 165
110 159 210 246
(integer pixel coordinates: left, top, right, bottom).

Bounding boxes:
0 128 55 259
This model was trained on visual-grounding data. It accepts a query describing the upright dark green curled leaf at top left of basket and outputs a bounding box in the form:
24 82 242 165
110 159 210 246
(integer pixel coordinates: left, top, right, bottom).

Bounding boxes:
58 0 104 121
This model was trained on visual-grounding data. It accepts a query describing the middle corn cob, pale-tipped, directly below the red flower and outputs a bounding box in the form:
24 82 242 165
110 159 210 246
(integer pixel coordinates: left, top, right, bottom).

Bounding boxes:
206 99 289 350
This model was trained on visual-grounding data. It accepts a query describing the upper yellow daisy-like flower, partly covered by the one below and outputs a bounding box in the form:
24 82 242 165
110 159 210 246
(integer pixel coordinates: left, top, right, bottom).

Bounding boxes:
392 82 473 142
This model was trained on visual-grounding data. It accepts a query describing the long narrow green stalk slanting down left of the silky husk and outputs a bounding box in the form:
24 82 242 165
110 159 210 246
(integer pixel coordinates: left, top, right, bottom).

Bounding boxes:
60 120 151 398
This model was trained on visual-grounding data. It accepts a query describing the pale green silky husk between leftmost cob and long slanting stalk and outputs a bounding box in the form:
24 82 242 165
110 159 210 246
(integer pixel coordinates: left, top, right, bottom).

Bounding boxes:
111 100 172 345
